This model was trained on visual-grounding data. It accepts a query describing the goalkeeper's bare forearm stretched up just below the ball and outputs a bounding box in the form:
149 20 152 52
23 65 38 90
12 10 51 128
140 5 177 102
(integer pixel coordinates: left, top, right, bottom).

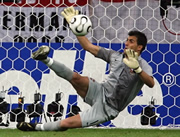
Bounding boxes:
77 36 100 56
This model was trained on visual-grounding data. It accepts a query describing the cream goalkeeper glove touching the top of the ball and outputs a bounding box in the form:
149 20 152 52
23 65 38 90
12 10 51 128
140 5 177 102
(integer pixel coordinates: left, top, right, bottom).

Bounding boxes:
61 6 79 23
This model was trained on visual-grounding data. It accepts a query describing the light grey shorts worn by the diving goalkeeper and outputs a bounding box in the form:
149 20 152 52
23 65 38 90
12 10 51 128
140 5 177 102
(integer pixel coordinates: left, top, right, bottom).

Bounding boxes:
79 78 119 127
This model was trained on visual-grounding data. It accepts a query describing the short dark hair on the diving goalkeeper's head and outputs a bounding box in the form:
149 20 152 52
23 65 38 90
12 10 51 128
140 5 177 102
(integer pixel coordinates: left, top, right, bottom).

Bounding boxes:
128 30 147 52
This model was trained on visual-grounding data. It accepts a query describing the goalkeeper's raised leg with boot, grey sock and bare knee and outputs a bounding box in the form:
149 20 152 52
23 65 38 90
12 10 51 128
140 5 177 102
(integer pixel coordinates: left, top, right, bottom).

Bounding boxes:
32 46 89 98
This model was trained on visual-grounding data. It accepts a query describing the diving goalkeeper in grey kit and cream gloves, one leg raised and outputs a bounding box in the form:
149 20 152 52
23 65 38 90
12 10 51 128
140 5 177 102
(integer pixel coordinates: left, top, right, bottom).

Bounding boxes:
17 7 154 131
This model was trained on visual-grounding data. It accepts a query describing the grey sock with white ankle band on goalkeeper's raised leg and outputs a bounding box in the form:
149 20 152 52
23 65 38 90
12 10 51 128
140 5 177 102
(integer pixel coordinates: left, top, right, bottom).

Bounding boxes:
42 57 73 81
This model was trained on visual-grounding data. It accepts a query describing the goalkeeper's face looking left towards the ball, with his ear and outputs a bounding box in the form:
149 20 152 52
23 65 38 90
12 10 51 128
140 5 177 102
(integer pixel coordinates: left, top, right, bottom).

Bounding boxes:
125 36 142 53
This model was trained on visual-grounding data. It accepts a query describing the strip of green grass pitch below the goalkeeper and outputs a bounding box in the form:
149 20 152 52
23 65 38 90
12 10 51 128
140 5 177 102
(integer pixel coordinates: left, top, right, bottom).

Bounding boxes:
0 128 180 137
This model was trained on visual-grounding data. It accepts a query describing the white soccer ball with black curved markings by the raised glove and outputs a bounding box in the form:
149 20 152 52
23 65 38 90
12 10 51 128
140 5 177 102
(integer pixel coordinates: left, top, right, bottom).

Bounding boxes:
69 15 92 36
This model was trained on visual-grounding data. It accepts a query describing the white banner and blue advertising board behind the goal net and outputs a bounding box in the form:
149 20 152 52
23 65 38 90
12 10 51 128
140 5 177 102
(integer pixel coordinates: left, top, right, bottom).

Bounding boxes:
0 0 180 128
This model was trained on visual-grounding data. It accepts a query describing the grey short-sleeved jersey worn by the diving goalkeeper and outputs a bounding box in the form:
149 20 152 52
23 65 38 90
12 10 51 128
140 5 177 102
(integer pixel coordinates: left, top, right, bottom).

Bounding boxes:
97 47 152 111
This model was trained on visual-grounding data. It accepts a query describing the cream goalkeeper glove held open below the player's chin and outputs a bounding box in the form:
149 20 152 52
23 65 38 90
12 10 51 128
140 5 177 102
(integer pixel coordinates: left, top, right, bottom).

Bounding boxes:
123 49 142 73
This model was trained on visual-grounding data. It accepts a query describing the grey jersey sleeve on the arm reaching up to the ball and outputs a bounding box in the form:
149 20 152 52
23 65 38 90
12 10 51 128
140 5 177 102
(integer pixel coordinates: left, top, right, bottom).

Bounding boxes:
96 47 115 63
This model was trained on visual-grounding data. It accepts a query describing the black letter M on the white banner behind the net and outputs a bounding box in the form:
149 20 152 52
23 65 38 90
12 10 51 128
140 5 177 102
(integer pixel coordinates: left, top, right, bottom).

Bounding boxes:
29 13 44 31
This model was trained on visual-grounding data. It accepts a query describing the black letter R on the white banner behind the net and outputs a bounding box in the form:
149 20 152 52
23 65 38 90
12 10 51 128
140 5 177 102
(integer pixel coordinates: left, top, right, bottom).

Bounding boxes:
16 12 26 30
